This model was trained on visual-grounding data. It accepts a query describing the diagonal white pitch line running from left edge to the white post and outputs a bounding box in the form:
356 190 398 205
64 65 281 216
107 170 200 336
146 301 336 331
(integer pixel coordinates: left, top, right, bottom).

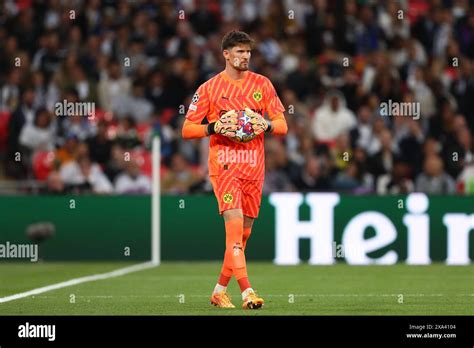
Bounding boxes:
0 262 157 303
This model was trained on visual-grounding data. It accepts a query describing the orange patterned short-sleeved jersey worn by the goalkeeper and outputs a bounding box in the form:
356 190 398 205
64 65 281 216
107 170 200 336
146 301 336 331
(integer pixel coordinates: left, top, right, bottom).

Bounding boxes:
186 71 285 180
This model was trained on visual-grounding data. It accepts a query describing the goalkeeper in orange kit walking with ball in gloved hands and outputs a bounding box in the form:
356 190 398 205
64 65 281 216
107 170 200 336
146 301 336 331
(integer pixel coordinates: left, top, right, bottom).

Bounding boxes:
182 31 287 309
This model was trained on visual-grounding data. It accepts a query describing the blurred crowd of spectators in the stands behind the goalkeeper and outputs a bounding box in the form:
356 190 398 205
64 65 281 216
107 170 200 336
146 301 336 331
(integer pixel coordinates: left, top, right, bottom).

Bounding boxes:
0 0 474 194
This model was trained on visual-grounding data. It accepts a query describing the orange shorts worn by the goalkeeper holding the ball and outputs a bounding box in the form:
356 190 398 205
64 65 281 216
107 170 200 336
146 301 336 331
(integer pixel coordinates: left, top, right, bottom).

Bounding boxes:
209 174 263 219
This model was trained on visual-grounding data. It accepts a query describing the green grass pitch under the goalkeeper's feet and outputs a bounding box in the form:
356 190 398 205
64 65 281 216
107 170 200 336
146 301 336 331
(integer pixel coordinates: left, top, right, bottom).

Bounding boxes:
0 262 474 315
